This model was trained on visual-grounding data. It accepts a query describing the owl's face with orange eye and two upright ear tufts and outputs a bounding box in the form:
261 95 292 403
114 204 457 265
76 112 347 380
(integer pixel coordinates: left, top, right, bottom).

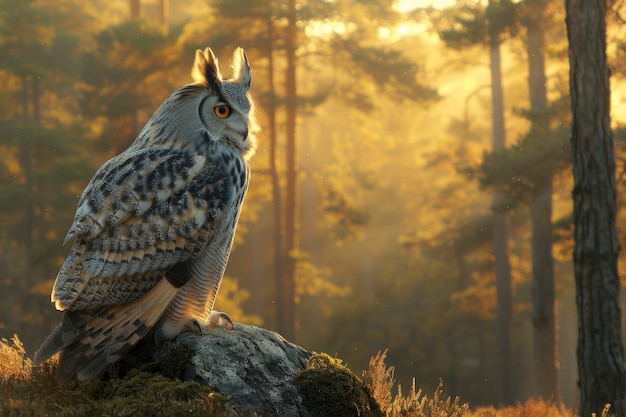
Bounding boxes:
191 48 258 157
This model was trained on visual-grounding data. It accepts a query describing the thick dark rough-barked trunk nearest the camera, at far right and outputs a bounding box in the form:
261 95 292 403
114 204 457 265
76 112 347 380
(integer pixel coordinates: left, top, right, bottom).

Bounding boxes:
565 0 626 417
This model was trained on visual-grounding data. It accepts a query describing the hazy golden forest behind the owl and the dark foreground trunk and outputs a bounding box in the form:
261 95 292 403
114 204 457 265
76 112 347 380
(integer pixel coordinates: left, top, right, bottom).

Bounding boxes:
0 0 626 406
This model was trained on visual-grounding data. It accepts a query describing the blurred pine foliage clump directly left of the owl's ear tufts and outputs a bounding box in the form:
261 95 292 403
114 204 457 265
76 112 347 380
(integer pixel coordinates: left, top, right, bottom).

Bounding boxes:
81 21 183 154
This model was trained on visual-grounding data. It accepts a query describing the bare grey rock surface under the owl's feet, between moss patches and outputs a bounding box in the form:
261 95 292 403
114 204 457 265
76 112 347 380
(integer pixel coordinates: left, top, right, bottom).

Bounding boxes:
154 323 312 416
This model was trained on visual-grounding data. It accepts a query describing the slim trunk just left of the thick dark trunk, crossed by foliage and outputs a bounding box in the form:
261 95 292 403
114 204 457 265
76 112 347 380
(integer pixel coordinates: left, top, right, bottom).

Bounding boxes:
525 10 560 402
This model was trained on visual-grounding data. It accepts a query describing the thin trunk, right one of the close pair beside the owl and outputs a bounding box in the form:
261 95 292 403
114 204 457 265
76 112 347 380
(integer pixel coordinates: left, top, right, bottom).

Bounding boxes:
279 0 298 341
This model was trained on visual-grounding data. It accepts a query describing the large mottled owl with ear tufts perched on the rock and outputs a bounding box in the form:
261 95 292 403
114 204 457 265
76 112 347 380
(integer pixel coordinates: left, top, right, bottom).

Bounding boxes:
35 48 257 383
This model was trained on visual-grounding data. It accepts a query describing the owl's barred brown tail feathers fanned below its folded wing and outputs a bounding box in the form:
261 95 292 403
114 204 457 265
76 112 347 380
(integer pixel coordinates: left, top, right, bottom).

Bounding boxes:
34 279 179 384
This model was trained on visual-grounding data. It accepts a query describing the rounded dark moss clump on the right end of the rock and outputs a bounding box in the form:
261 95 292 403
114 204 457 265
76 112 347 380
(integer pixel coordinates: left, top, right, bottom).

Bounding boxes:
296 353 383 417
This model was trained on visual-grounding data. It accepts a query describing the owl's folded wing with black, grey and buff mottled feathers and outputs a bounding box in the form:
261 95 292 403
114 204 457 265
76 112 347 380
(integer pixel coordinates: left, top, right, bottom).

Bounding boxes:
52 149 234 310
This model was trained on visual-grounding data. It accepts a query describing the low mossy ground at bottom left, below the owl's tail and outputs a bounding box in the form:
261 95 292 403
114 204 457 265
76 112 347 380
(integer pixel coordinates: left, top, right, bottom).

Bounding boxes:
0 365 236 417
